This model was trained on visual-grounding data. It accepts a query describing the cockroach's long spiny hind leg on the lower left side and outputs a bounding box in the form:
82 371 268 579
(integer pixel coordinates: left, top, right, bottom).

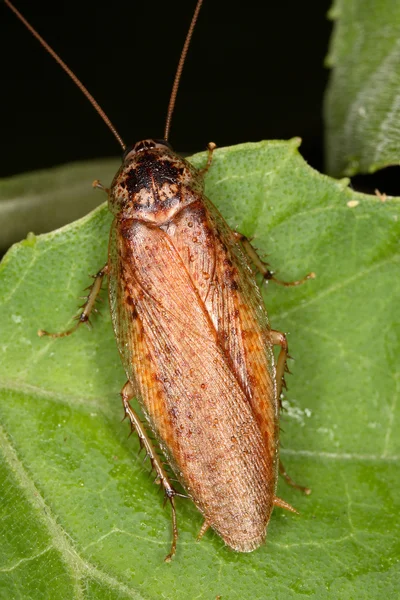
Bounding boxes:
121 381 180 562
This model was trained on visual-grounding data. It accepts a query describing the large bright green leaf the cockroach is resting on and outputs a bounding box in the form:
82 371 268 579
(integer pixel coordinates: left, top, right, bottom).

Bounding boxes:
0 140 400 600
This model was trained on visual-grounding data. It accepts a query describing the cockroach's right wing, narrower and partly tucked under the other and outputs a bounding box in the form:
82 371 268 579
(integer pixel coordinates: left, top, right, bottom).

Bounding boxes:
164 196 279 464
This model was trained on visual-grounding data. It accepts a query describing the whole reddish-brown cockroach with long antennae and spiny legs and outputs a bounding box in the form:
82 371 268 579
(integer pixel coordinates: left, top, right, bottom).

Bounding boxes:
5 0 314 561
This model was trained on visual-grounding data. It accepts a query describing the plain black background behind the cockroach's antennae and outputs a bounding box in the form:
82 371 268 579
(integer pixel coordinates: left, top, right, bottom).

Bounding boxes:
0 0 331 176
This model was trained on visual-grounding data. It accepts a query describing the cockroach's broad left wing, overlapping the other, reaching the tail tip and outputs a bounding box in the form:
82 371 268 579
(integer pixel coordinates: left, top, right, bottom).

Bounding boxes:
109 217 276 552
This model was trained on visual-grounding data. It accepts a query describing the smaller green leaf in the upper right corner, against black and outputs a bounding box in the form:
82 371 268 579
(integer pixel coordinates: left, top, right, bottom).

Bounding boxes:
325 0 400 175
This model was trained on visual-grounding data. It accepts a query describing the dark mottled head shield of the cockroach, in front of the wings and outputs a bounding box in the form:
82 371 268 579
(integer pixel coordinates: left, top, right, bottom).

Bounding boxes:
109 139 203 225
